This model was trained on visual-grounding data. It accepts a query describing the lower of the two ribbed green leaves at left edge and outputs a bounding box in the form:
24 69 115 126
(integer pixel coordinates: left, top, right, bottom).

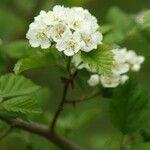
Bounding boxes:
1 96 41 113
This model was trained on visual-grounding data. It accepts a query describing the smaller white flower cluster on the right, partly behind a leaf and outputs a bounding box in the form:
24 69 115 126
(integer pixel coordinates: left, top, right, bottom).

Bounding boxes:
72 48 144 88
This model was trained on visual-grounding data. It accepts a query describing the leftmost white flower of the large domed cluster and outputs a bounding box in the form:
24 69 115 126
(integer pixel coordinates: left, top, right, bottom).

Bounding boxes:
26 22 51 49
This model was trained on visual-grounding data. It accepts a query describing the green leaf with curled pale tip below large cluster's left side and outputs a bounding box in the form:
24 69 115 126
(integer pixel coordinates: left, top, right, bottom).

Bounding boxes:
14 53 55 74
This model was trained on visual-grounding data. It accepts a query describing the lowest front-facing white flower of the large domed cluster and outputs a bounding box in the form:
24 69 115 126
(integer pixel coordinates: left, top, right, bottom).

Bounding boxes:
56 31 82 56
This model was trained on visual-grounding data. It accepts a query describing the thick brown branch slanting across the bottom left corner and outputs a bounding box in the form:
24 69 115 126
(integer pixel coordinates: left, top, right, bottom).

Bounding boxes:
0 116 81 150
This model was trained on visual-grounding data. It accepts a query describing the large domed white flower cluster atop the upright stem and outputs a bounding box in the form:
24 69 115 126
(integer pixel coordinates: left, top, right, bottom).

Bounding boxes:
26 5 103 56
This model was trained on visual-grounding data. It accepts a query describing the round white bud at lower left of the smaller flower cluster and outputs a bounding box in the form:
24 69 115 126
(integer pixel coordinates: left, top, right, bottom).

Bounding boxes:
88 74 100 86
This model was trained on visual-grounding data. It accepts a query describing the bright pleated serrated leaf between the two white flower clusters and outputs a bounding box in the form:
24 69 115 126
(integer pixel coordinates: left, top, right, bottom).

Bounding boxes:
81 44 113 74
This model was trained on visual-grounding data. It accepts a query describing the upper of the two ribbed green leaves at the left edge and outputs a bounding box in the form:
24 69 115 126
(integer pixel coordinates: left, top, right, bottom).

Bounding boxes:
0 74 39 98
